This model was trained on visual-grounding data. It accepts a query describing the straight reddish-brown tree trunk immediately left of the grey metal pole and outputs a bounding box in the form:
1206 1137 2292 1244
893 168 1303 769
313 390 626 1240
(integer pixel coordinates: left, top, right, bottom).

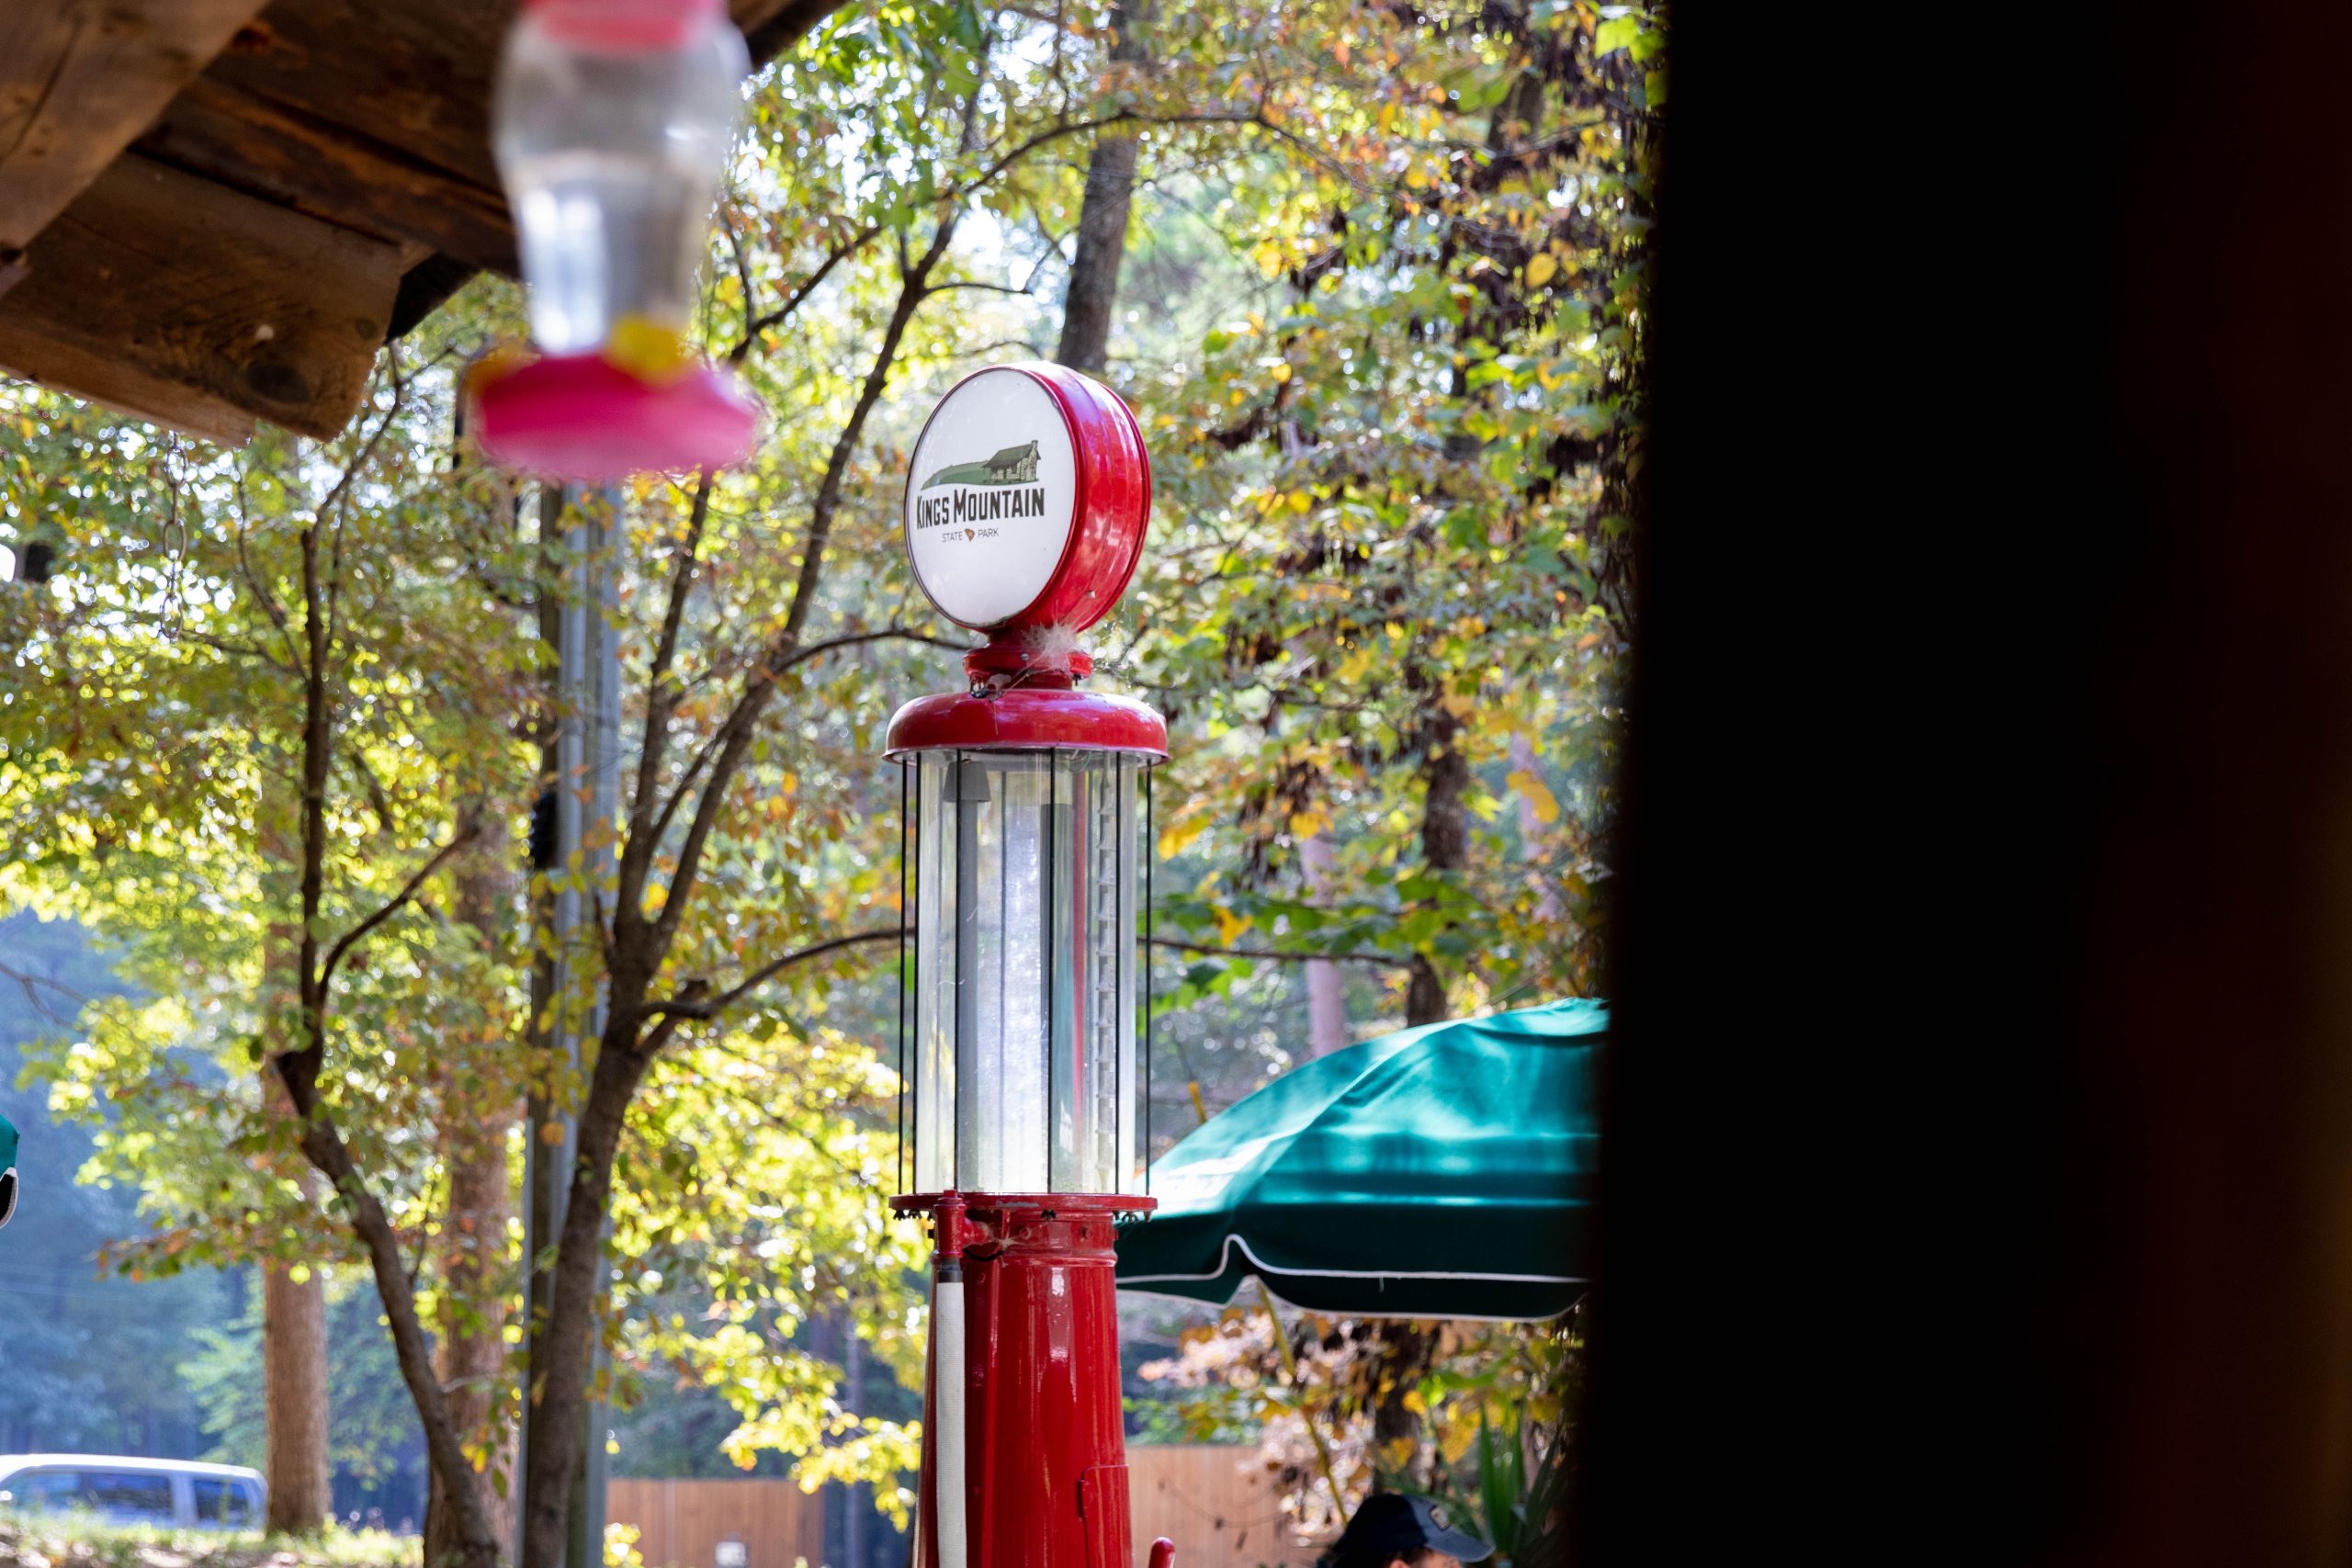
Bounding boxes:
437 802 515 1568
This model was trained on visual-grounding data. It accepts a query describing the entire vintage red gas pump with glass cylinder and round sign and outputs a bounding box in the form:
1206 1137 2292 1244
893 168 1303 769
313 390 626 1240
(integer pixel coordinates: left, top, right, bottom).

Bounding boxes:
889 365 1173 1568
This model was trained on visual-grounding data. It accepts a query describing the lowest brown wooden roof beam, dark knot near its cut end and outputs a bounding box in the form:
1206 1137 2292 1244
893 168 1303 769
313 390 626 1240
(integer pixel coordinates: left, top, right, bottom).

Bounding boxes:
0 152 402 440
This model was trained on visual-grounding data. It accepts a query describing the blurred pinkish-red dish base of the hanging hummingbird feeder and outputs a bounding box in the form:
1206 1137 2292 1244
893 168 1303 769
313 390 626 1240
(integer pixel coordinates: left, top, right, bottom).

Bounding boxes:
473 355 760 484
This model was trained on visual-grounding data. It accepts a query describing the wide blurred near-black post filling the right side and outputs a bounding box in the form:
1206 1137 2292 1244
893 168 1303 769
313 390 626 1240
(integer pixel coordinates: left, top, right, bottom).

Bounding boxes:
1578 0 2352 1568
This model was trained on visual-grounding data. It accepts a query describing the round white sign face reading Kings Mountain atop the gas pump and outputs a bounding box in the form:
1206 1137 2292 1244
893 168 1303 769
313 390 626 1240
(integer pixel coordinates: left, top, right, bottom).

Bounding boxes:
906 367 1077 627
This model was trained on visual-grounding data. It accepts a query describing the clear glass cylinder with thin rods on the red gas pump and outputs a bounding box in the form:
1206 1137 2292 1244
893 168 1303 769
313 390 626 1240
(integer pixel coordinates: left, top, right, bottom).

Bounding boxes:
910 748 1143 1194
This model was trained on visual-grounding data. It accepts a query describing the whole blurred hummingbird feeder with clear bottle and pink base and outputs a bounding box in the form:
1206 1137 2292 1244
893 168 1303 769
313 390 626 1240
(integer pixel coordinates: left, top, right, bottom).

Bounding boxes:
473 0 760 482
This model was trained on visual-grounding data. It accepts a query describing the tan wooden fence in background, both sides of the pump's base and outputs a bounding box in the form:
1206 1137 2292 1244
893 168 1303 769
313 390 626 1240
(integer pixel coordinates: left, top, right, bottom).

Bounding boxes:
605 1443 1315 1568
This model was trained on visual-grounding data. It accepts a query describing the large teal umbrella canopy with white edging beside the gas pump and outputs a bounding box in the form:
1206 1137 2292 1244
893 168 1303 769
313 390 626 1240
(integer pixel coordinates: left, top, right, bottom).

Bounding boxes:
1120 1001 1609 1319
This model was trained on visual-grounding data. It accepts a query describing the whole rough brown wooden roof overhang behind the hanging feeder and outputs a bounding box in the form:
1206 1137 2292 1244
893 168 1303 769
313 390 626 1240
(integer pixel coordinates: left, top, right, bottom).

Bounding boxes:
0 0 842 442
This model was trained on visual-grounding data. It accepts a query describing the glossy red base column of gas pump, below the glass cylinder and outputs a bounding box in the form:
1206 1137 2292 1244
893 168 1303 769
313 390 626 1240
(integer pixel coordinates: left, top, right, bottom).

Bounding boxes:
891 1192 1173 1568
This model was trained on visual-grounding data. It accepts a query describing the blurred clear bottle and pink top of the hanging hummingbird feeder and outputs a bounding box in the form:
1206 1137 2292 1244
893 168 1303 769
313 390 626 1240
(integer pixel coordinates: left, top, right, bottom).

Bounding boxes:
496 0 751 355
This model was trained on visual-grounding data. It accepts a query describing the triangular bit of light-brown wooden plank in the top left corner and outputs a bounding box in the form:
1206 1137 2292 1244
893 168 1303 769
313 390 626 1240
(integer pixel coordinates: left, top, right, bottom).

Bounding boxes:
0 0 261 252
